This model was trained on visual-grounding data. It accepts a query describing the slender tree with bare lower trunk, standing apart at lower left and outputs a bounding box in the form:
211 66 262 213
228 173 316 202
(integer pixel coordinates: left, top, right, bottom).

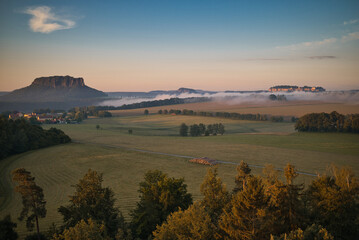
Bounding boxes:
12 168 46 239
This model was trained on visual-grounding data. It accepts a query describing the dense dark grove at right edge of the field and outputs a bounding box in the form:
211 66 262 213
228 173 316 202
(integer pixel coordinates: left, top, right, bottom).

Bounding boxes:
295 111 359 133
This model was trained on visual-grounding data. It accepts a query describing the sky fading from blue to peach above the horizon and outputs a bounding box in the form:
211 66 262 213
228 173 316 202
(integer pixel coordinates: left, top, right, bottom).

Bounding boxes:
0 0 359 91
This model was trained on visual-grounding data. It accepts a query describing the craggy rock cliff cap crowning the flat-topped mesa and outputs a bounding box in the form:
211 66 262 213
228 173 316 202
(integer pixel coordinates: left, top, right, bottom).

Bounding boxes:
31 76 85 88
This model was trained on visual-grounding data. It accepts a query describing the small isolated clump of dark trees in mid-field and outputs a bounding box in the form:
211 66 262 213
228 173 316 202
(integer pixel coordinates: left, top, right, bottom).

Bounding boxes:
179 123 225 137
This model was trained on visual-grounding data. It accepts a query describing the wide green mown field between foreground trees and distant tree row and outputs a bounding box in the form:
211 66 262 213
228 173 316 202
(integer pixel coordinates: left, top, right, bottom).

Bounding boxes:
0 106 359 236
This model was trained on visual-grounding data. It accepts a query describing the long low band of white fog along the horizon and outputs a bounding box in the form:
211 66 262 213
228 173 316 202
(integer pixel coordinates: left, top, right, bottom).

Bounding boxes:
98 91 359 107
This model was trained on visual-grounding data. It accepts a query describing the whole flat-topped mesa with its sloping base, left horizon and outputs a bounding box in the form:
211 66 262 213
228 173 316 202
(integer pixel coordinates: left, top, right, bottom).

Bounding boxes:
0 76 107 102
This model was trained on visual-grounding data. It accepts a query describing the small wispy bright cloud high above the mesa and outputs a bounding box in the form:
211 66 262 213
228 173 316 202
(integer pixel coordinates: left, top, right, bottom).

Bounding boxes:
25 6 75 33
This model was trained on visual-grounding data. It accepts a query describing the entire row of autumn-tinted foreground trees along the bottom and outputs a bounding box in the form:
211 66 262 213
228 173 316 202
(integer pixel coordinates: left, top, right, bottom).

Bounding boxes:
0 161 359 240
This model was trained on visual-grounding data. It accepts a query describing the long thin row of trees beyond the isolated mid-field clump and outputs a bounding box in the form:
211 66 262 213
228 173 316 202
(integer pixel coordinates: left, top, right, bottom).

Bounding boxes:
158 109 268 121
